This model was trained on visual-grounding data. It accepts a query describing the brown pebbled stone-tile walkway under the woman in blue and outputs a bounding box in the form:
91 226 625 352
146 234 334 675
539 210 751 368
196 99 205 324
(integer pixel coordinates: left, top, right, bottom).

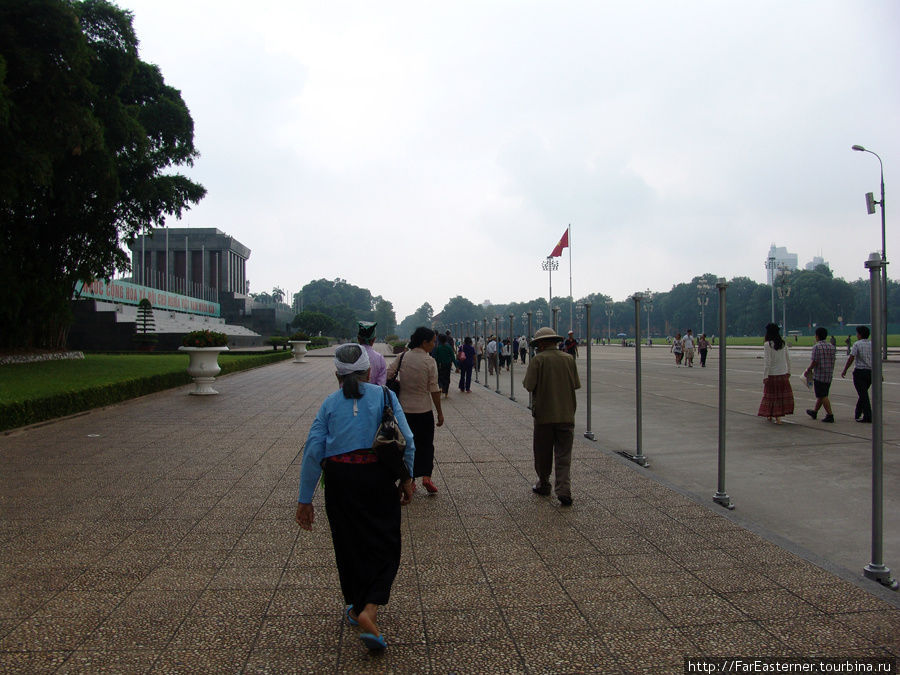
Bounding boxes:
0 357 900 673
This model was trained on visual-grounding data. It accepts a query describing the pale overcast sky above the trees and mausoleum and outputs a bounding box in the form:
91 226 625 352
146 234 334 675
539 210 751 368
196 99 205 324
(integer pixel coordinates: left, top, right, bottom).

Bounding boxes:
117 0 900 321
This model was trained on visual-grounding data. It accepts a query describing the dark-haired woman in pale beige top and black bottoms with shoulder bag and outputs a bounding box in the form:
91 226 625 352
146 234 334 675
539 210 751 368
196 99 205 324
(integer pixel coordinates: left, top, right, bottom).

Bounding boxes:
387 326 444 494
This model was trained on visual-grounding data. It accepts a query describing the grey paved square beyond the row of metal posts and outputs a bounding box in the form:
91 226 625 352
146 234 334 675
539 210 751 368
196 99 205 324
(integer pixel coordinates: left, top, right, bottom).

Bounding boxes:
468 346 900 576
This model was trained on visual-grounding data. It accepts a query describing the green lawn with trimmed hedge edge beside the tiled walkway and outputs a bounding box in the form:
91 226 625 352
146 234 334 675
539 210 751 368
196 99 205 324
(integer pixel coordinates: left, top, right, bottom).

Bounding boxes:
0 351 291 430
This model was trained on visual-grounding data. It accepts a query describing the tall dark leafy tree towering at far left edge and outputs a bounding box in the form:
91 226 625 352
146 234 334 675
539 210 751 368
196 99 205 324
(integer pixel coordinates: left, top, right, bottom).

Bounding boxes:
0 0 205 348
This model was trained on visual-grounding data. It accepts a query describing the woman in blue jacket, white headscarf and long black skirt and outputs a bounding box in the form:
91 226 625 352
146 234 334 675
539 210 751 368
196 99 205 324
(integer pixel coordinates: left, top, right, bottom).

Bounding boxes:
295 344 415 650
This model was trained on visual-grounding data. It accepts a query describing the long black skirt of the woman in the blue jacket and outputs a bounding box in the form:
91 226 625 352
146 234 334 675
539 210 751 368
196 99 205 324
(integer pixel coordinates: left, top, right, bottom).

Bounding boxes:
324 461 400 611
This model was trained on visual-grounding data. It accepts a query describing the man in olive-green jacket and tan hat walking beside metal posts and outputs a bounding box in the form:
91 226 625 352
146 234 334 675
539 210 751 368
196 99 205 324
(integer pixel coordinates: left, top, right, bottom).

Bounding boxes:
522 327 581 506
